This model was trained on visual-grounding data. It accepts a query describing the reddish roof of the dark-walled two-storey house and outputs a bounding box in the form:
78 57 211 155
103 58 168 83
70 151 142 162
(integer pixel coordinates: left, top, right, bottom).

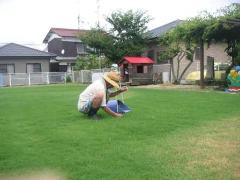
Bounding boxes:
43 28 88 43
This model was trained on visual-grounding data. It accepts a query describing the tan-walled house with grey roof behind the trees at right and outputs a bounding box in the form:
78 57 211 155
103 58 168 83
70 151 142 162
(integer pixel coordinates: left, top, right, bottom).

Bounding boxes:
144 20 231 81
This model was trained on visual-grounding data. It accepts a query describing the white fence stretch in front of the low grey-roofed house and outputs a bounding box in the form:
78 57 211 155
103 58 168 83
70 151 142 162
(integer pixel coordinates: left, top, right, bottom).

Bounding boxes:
0 72 73 86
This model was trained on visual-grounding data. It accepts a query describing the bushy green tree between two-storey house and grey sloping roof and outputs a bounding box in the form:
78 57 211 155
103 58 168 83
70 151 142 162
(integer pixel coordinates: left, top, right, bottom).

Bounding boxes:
83 10 150 62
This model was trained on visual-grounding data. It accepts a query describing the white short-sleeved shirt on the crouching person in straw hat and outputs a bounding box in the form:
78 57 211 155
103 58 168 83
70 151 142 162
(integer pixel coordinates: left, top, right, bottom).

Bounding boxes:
78 78 107 110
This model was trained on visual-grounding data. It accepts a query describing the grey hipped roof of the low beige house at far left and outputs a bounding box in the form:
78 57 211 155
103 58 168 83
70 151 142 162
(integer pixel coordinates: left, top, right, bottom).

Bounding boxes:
0 43 56 57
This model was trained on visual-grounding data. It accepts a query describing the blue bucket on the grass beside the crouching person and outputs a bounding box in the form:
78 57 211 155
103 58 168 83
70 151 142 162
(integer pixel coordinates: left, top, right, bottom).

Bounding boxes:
107 100 131 113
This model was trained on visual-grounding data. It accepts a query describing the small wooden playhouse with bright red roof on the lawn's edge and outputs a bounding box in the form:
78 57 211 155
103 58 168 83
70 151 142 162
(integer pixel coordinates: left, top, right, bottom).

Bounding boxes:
118 57 154 85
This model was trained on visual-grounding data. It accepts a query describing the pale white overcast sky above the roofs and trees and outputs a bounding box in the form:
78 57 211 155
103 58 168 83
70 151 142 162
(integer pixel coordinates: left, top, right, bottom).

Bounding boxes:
0 0 237 49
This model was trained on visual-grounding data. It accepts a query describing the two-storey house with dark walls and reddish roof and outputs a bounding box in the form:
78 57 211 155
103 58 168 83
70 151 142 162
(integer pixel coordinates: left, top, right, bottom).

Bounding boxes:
43 28 88 72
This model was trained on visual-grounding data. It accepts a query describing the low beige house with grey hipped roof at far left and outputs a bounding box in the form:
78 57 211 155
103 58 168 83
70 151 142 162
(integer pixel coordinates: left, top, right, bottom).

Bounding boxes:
0 43 56 73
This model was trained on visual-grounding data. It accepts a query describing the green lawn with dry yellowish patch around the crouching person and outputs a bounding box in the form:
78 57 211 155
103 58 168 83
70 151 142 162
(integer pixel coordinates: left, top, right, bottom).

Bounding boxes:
0 85 240 180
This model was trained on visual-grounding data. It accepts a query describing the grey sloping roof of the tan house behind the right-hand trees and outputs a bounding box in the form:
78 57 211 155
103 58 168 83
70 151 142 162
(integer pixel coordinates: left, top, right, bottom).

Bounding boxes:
148 19 183 38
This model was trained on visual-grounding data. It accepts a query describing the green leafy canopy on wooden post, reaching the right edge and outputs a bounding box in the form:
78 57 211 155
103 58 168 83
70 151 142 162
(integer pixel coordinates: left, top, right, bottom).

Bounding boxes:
161 4 240 88
